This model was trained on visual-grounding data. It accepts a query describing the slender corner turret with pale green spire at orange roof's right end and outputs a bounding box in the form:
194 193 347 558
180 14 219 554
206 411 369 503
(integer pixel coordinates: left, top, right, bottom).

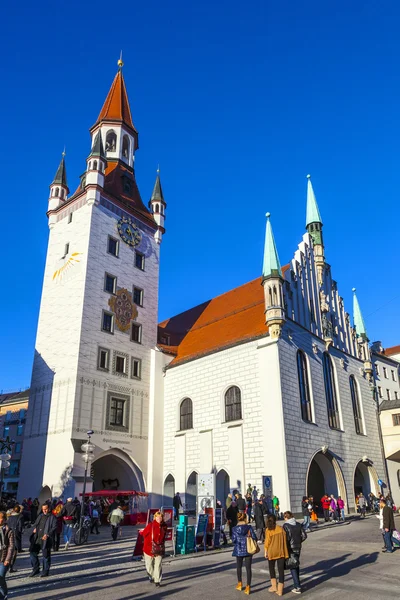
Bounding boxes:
262 213 285 339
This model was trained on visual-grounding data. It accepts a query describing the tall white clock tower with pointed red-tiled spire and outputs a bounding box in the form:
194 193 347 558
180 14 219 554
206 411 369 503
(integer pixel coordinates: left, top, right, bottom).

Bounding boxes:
20 60 166 500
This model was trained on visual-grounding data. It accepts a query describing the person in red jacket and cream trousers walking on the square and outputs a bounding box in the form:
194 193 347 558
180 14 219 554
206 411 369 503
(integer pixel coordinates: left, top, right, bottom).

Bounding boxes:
143 512 167 587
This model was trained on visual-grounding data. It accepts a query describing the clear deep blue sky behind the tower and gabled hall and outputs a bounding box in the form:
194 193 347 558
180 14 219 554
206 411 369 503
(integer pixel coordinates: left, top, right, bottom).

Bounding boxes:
0 0 400 390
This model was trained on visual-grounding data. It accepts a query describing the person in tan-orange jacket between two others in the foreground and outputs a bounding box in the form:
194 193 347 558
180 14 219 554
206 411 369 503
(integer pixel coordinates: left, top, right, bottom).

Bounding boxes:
264 515 289 596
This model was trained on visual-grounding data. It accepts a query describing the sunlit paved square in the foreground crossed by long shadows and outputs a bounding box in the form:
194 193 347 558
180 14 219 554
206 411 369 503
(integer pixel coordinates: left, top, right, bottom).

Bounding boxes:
8 516 400 600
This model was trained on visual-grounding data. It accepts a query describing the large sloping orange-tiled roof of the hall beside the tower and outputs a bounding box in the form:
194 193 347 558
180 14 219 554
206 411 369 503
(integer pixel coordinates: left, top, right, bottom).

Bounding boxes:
158 265 289 366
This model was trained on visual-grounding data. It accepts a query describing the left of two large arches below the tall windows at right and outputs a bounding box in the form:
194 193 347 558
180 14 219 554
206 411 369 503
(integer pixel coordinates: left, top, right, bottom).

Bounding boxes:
306 451 347 508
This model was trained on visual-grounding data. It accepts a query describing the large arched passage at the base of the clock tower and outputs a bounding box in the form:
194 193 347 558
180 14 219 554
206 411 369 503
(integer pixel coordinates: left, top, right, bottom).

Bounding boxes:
91 449 145 492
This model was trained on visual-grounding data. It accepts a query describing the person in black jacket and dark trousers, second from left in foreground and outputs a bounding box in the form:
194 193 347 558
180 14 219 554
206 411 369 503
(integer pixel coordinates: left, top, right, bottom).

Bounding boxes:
29 503 57 577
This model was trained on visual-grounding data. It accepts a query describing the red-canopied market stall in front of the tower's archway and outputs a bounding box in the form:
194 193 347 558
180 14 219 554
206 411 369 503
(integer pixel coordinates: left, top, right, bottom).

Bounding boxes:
80 490 149 525
